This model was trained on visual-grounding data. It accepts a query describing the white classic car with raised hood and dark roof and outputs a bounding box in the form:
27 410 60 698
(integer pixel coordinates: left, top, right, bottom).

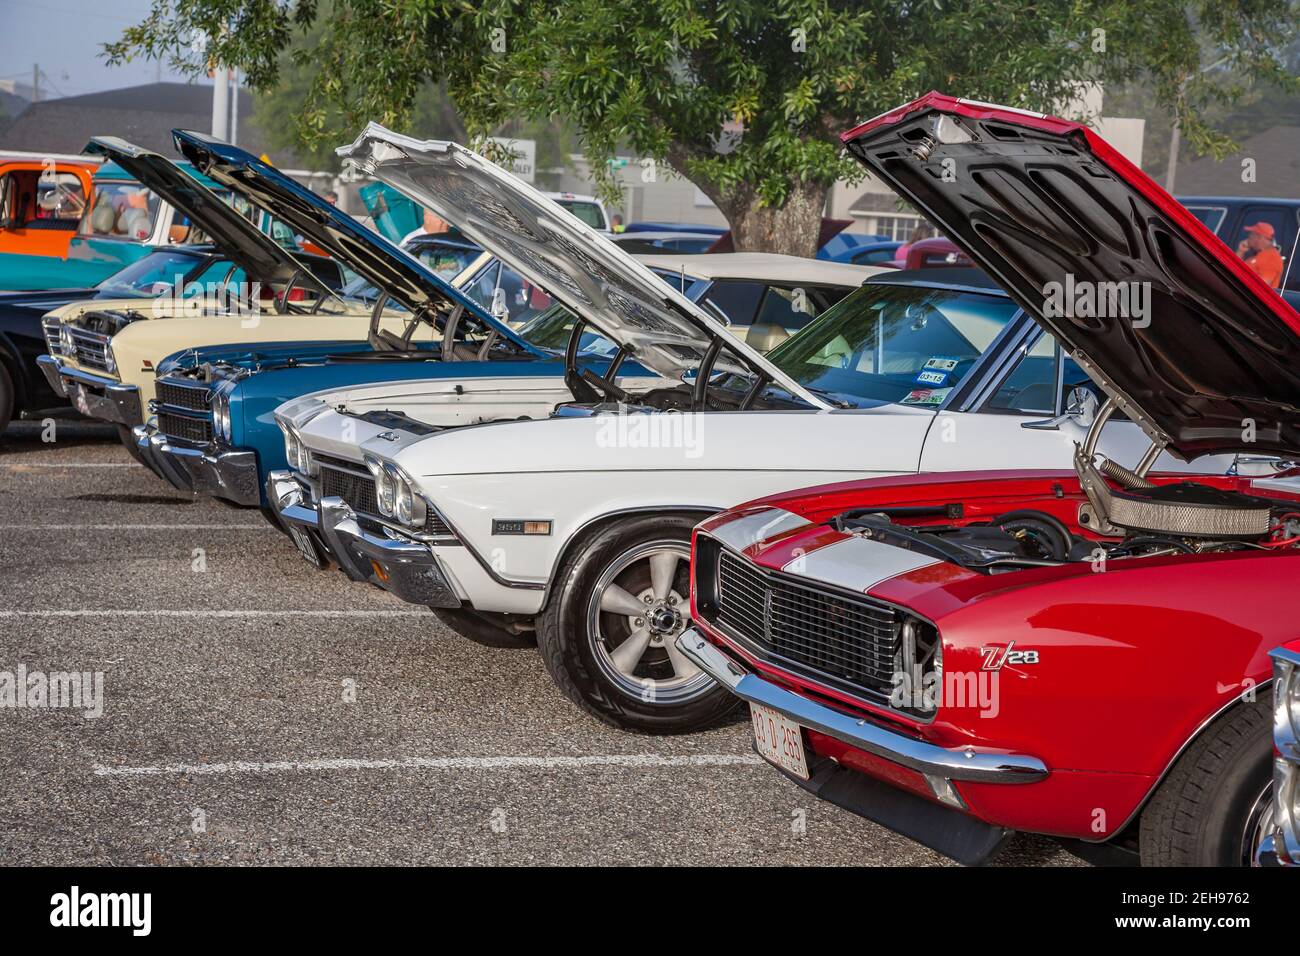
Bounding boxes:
268 125 1274 732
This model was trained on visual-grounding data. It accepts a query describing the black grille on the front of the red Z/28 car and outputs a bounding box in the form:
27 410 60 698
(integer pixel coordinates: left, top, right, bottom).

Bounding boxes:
715 538 900 697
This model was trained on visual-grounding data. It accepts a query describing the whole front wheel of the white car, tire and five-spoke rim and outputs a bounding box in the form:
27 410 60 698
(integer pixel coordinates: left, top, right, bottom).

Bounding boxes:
538 516 737 734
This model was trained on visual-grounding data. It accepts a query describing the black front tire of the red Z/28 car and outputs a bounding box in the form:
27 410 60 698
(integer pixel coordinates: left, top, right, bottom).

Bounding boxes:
1139 701 1273 866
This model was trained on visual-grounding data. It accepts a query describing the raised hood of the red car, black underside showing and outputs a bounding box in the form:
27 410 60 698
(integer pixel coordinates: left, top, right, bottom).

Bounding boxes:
842 92 1300 459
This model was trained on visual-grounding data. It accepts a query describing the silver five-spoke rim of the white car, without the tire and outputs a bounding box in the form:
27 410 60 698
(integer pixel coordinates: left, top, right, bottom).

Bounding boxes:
586 538 714 705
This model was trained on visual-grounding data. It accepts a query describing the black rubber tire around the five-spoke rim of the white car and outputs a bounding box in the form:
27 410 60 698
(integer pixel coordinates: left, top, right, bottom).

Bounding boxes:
537 515 740 734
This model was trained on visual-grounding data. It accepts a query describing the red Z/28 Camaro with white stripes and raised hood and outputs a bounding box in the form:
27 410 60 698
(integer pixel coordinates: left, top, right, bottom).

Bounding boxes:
679 94 1300 865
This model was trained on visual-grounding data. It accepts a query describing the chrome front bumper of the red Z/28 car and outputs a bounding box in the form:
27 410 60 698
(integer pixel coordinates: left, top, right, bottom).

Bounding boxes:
677 628 1048 783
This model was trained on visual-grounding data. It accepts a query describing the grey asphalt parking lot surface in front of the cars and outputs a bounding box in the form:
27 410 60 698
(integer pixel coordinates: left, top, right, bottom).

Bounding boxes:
0 424 1078 865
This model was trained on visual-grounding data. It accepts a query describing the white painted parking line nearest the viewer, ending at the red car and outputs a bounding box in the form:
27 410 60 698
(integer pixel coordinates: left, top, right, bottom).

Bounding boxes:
95 753 763 777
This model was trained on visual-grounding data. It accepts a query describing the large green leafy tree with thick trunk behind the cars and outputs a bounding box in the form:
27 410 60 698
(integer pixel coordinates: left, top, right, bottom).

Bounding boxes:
108 0 1300 255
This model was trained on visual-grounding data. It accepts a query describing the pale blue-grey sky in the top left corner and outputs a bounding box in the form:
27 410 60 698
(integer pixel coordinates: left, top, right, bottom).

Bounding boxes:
0 0 197 98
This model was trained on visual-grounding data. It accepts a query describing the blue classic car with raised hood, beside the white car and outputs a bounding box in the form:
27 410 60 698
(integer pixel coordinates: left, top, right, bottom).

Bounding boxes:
135 130 658 515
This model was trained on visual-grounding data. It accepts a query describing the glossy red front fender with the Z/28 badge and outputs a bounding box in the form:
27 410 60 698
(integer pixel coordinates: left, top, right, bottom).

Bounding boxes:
930 551 1300 838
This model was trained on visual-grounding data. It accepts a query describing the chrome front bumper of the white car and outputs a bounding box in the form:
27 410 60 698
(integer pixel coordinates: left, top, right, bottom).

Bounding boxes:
267 471 460 607
